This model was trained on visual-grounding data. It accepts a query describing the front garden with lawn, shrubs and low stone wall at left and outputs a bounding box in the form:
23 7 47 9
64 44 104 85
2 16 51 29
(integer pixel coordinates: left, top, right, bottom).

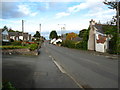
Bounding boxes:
0 41 42 55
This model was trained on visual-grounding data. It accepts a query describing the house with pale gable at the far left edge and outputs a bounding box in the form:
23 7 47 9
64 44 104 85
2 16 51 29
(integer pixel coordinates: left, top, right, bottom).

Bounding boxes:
0 29 10 42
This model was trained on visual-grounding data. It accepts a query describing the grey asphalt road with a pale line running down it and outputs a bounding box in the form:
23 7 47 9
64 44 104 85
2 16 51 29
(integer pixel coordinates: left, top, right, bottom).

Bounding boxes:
3 42 118 88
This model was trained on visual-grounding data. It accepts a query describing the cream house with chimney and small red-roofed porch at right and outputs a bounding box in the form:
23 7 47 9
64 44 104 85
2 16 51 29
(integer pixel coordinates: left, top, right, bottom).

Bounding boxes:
88 20 110 52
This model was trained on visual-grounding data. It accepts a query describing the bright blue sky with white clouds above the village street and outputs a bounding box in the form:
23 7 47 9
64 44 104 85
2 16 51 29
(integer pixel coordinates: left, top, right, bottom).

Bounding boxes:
0 0 116 38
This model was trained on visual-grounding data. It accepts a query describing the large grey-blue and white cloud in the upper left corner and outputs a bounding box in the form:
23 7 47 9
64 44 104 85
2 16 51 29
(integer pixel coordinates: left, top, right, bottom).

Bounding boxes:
0 2 37 19
